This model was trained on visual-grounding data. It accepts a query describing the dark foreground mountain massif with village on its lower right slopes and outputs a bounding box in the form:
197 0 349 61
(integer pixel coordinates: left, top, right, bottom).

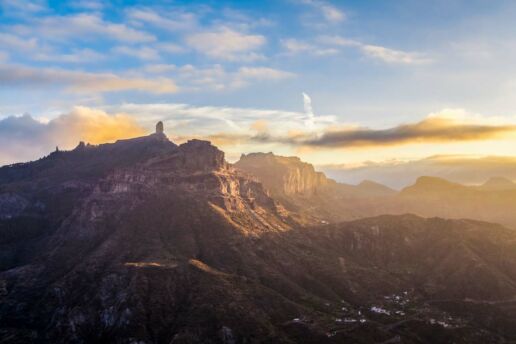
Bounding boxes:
0 132 516 344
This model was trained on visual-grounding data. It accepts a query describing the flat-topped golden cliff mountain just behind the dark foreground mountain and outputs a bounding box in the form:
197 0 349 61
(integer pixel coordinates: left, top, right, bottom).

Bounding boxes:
234 153 396 223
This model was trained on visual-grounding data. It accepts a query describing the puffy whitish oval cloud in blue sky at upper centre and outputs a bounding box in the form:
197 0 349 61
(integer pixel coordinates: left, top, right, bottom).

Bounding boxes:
186 27 266 62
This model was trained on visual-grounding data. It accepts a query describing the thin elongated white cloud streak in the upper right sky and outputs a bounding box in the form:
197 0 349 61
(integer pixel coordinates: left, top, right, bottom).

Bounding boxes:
318 36 432 65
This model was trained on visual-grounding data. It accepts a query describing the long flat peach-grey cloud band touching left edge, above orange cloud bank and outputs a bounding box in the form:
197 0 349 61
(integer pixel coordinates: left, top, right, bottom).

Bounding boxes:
0 64 177 94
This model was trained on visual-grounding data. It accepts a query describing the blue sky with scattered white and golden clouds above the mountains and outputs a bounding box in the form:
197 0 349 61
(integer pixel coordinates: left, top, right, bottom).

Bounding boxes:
0 0 516 188
